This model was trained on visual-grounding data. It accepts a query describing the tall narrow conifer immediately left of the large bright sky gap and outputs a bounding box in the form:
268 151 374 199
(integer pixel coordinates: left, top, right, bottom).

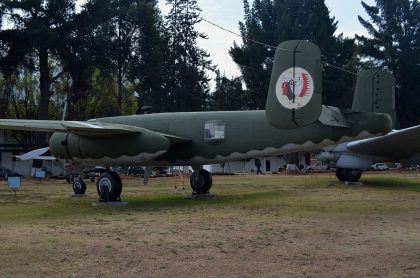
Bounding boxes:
161 0 213 111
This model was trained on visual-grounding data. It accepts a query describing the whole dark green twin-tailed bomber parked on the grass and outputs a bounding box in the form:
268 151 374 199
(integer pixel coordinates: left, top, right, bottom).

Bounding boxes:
0 40 395 201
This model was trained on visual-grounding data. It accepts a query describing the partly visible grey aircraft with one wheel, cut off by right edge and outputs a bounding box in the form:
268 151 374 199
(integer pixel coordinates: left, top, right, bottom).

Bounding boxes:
317 126 420 182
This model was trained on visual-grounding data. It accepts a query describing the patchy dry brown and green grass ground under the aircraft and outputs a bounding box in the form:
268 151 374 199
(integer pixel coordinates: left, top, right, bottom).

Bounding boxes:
0 174 420 277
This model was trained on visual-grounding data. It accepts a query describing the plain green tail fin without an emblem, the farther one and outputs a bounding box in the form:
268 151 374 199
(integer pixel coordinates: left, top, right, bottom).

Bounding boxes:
352 69 396 125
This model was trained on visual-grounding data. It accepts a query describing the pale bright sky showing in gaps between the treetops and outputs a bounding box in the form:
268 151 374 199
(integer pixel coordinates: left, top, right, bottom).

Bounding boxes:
159 0 375 77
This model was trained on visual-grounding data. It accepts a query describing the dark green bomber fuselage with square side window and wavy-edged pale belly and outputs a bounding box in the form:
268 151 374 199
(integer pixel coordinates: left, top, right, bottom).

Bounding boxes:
51 110 391 165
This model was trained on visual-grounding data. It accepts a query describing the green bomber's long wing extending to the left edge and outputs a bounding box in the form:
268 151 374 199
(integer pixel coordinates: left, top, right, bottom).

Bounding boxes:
0 119 191 144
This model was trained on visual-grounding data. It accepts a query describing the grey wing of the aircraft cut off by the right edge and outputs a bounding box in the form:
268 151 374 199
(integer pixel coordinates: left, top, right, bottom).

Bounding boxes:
347 125 420 158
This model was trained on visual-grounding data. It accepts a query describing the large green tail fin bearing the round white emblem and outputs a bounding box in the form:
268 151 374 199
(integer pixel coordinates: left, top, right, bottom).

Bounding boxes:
266 40 322 129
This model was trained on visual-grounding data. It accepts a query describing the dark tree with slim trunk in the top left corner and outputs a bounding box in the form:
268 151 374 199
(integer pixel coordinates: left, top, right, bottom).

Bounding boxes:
0 0 75 119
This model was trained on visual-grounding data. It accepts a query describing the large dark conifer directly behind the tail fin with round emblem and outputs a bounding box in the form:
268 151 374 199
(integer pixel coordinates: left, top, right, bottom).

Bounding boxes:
229 0 354 109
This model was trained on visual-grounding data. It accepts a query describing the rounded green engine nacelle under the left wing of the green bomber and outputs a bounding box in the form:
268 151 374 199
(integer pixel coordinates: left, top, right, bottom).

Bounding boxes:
50 131 171 165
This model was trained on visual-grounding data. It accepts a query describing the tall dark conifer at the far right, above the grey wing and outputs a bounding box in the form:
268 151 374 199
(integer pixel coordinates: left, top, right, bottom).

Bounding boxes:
357 0 420 128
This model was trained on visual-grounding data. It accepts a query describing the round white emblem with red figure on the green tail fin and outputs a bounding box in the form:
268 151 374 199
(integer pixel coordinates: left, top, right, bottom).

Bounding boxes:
276 67 314 109
